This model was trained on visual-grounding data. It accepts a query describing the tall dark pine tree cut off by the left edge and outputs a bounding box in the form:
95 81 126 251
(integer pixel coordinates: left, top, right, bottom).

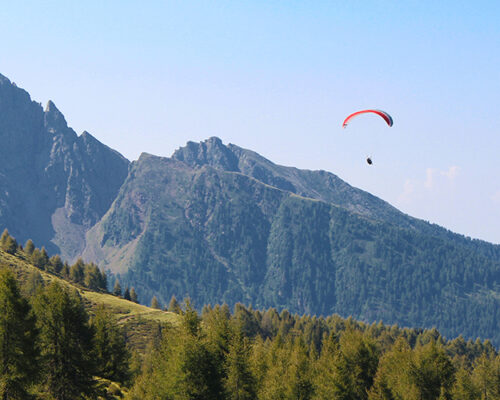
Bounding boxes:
0 268 39 399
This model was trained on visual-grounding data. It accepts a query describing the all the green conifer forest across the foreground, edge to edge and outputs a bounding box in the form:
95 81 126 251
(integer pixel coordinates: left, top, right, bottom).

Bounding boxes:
0 230 500 400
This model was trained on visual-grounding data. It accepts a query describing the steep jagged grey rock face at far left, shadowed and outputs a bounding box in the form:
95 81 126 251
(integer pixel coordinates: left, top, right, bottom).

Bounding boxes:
0 75 129 259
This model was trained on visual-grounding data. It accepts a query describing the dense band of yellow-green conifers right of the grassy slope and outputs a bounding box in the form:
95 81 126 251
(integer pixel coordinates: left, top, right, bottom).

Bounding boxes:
128 302 500 400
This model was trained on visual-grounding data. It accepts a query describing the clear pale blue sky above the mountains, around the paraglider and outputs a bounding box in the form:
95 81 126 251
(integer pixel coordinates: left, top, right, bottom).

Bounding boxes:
0 0 500 243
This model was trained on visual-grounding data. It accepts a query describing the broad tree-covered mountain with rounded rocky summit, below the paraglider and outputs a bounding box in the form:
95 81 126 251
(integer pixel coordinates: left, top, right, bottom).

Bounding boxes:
83 138 500 343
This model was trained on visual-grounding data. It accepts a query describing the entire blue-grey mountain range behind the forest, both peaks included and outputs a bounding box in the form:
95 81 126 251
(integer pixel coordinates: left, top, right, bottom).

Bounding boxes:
0 74 500 345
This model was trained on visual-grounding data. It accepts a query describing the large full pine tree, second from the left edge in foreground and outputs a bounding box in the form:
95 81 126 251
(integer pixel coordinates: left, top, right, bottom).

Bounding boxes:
33 282 95 400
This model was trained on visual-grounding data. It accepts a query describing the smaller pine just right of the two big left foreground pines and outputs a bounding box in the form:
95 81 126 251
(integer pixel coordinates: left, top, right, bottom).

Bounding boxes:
91 306 130 384
